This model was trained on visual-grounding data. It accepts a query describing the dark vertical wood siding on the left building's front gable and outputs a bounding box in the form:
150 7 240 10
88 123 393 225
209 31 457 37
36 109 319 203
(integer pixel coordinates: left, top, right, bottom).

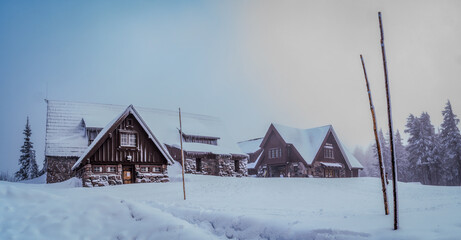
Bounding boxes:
89 114 167 164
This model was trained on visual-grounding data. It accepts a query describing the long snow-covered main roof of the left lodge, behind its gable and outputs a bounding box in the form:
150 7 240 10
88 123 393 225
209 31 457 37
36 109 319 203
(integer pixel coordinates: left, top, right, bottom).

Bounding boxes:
45 100 245 160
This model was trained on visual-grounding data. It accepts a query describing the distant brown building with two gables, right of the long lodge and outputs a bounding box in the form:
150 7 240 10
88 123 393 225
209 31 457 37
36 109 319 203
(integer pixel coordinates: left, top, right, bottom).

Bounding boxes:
240 124 363 178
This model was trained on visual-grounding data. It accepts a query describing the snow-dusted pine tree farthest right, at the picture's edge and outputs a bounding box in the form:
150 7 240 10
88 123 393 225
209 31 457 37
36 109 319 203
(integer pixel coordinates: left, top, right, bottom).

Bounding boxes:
440 101 461 185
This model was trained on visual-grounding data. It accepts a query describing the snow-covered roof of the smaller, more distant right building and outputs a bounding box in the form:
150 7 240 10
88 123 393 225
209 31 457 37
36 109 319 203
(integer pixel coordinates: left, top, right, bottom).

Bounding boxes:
272 123 363 168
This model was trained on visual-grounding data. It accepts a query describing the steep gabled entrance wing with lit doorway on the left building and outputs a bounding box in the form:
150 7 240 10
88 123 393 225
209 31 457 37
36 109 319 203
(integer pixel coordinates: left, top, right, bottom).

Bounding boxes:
72 105 172 187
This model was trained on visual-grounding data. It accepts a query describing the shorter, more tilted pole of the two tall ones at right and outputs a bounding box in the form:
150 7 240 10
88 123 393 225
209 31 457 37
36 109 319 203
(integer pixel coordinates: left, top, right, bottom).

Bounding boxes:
360 54 389 215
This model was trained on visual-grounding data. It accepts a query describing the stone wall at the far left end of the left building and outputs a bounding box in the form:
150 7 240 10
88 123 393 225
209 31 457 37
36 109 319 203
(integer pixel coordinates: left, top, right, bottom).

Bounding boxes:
45 156 78 183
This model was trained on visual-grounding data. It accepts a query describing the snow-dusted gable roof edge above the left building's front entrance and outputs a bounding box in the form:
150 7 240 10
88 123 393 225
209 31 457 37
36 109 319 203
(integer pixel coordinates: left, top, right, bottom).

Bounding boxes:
72 105 174 170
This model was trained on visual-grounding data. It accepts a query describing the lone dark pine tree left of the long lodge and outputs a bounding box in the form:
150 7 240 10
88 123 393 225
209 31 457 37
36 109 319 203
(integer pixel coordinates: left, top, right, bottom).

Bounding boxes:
15 117 38 181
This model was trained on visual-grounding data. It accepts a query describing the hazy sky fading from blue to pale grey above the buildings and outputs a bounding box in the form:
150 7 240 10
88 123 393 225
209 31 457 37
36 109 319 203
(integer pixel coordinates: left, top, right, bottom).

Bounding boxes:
0 0 461 173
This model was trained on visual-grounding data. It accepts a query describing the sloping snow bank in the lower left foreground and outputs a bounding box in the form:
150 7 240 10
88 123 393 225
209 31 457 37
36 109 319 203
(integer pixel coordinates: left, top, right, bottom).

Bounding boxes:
0 183 214 239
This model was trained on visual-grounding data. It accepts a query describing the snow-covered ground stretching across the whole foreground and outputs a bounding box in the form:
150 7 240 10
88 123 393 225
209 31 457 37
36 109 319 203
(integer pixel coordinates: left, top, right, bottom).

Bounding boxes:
0 167 461 239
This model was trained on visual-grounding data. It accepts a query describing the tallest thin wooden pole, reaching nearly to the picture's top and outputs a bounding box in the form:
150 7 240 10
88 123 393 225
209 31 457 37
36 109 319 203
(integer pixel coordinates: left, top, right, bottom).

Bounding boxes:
378 12 399 230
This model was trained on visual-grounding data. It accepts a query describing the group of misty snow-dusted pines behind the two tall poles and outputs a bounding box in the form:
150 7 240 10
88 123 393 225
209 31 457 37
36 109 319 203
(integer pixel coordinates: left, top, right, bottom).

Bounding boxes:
354 101 461 186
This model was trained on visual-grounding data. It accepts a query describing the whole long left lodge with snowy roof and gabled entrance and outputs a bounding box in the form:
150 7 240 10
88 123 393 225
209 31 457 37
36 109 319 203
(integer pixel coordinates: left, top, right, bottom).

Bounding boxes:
45 100 248 186
